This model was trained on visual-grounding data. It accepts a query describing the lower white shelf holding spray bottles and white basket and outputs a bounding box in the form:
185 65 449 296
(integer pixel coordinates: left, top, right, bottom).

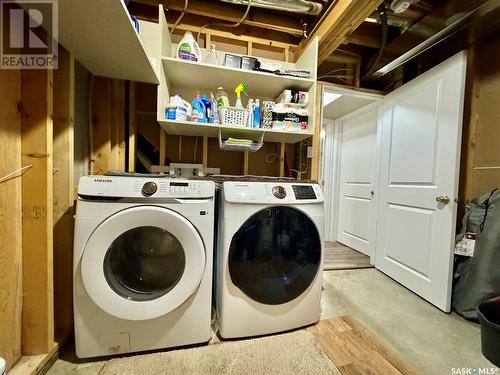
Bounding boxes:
158 120 313 143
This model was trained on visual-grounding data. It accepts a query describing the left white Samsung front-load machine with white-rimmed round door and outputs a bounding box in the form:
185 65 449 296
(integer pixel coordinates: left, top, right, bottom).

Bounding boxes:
73 176 215 358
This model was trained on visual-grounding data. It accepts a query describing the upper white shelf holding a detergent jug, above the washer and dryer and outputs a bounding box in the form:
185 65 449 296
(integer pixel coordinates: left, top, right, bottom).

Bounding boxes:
162 57 315 99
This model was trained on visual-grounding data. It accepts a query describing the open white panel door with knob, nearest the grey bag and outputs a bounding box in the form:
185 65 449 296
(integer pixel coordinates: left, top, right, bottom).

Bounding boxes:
375 52 466 311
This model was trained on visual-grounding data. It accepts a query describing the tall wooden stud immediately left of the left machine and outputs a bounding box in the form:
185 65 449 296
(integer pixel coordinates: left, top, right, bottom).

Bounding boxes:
53 47 75 345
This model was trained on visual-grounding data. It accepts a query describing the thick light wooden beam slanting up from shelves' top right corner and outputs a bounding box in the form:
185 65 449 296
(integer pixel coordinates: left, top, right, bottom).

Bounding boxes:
298 0 383 64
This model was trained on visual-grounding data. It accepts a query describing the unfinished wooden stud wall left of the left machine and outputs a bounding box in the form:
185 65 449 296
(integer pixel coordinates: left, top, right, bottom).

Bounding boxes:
0 47 82 373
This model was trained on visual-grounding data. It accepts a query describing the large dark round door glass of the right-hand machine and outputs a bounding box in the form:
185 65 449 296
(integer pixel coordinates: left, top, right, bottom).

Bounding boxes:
228 206 321 305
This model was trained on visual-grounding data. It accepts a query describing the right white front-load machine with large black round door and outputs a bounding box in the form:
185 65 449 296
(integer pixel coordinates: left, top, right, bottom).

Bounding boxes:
215 182 324 338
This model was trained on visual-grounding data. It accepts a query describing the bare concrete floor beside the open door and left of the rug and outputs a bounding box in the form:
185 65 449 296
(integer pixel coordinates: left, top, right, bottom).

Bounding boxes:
48 269 492 375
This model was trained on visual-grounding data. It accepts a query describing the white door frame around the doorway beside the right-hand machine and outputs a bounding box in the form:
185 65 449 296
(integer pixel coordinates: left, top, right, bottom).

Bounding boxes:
321 85 384 264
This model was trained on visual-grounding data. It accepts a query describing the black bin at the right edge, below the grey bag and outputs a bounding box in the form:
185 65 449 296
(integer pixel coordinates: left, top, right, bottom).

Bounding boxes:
477 297 500 366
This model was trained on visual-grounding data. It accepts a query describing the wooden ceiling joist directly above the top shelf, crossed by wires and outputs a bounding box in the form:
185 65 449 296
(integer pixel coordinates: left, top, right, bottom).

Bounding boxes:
131 0 303 36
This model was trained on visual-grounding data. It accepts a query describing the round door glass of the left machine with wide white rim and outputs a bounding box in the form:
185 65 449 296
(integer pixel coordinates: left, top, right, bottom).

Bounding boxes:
104 226 186 301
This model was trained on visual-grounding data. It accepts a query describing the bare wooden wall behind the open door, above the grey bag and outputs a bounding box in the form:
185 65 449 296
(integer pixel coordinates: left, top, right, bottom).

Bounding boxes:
459 31 500 218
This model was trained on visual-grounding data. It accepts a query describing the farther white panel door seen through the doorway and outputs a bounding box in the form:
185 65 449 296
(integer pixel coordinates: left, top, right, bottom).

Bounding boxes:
337 102 379 256
